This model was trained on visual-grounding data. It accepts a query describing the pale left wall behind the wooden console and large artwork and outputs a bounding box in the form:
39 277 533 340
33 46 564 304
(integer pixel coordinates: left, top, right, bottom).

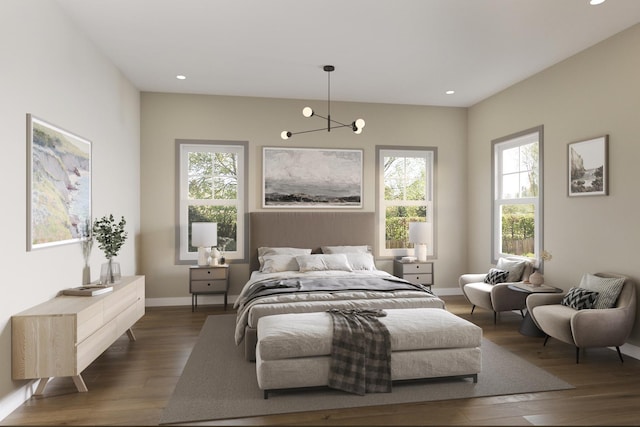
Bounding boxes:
0 0 140 419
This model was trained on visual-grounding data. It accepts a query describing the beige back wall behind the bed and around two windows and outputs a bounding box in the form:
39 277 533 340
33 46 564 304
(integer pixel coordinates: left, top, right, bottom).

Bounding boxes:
141 93 467 305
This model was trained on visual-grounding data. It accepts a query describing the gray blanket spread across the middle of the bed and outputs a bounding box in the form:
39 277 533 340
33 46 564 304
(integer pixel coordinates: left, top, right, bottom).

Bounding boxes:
238 276 433 307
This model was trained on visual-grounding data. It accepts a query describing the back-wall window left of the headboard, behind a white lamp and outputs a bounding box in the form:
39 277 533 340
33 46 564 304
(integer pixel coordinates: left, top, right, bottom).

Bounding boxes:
176 140 247 264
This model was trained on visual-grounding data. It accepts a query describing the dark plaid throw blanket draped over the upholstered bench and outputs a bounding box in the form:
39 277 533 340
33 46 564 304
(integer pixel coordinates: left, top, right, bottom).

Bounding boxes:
327 309 391 396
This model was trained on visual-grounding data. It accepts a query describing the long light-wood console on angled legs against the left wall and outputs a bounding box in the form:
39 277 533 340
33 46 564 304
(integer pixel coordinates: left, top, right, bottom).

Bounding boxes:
11 276 145 395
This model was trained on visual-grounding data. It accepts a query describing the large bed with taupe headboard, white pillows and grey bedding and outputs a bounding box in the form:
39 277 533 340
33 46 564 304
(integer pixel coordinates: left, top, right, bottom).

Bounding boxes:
234 212 445 360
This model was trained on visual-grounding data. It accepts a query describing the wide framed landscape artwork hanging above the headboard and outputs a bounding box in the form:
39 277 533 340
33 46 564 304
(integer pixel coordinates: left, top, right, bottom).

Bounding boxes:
262 147 363 208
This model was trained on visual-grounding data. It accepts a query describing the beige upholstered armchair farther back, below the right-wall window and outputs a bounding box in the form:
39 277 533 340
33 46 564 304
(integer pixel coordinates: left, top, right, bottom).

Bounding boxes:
458 257 533 323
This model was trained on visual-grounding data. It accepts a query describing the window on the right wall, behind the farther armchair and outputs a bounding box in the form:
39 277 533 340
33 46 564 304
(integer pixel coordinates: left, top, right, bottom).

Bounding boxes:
492 126 543 263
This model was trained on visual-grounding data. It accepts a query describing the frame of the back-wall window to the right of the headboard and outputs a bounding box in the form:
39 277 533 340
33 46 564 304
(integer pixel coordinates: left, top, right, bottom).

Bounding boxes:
376 145 438 260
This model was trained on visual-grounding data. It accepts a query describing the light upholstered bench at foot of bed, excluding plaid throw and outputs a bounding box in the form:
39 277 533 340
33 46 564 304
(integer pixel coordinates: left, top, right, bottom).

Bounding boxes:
256 308 482 399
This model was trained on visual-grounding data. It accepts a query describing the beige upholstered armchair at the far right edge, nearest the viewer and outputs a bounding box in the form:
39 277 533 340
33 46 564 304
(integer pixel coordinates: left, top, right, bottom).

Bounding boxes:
527 273 636 363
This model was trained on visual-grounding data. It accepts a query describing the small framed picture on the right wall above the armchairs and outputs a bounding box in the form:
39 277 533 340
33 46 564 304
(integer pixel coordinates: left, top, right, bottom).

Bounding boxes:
567 135 609 197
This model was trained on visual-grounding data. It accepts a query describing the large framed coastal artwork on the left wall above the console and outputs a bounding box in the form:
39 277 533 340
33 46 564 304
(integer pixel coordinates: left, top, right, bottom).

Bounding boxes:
27 114 91 251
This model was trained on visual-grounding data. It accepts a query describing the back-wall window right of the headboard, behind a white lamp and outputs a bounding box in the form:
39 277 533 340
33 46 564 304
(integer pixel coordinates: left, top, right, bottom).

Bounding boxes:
376 147 437 257
